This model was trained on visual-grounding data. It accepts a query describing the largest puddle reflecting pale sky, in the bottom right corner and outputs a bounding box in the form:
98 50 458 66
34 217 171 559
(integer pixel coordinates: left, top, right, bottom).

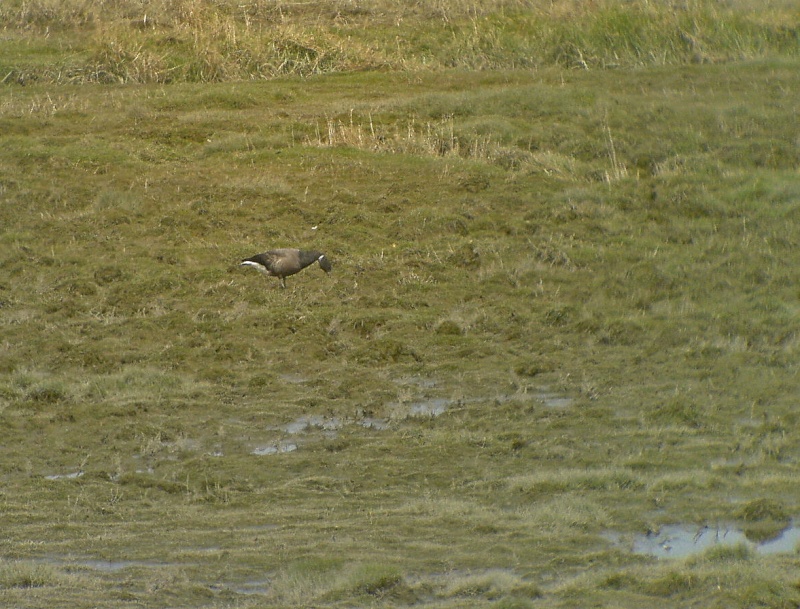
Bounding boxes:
605 524 800 558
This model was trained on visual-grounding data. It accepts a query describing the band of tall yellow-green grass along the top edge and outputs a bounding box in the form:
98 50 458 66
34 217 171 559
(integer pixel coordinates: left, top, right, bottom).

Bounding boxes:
0 0 800 83
